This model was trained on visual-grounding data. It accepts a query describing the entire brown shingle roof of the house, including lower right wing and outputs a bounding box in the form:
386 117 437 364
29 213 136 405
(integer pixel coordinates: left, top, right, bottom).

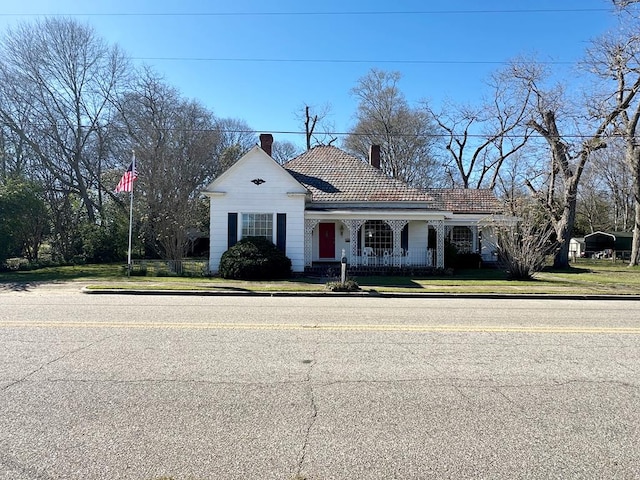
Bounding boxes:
284 146 502 214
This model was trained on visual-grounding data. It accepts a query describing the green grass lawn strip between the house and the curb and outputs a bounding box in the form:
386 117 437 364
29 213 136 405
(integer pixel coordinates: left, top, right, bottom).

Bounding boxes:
0 260 640 295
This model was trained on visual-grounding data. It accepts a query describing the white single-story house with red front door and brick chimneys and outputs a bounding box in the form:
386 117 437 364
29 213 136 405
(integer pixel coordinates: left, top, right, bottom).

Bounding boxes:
203 134 508 273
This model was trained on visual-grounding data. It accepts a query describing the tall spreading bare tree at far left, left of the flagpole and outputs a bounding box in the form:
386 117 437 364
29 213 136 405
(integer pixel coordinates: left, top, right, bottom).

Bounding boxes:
0 17 128 222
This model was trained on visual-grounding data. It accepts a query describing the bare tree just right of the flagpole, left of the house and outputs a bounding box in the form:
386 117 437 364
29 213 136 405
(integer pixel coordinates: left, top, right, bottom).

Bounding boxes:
120 70 219 261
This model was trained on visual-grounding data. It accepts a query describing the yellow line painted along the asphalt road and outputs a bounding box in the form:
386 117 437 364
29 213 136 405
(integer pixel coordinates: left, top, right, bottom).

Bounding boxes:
0 320 640 335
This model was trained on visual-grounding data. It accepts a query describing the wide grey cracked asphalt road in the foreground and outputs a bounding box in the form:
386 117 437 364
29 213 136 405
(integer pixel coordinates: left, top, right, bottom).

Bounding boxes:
0 288 640 480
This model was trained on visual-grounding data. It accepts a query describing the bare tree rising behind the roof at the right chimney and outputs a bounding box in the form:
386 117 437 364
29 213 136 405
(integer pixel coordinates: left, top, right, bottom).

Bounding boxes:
344 69 441 187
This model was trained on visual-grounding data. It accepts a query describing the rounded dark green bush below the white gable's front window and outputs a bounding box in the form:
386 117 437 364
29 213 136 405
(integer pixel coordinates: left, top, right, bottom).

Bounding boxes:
219 237 291 280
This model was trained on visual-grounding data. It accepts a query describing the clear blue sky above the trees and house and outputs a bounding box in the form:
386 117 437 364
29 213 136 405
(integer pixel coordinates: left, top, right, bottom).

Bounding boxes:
0 0 614 149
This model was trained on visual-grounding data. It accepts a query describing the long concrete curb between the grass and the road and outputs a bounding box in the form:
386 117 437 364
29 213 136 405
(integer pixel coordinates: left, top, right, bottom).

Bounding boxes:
80 287 640 301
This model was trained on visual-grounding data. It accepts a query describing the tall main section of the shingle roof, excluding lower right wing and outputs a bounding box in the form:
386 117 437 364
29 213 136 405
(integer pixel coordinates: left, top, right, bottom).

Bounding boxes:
283 145 442 210
